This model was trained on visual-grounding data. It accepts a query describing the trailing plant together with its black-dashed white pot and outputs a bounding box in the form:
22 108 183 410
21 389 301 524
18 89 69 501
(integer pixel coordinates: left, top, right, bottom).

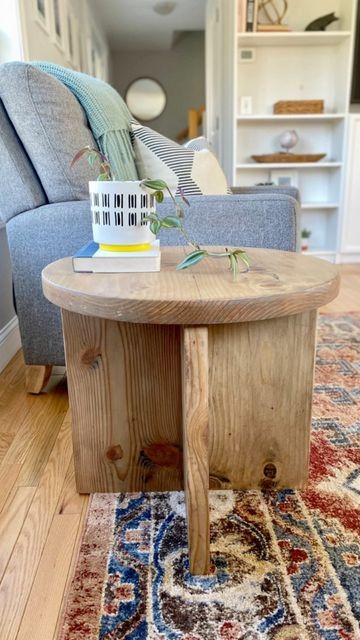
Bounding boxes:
71 147 249 278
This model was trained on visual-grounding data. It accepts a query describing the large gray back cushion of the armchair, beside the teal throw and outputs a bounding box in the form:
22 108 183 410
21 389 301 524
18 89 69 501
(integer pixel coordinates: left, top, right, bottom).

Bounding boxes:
0 62 96 202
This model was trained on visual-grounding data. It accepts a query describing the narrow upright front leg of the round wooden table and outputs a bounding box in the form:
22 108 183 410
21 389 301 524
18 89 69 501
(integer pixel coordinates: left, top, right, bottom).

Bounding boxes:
181 327 210 575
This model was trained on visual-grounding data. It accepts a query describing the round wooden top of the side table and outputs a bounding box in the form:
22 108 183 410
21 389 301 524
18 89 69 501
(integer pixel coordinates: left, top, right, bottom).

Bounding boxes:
42 247 339 324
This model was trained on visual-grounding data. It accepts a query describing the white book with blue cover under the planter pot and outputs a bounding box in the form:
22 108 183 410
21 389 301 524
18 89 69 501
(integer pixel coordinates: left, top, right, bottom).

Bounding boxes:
72 240 161 273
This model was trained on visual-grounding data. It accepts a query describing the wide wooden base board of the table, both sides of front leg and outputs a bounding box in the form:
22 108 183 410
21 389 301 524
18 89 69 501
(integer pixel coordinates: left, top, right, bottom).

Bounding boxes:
59 311 316 493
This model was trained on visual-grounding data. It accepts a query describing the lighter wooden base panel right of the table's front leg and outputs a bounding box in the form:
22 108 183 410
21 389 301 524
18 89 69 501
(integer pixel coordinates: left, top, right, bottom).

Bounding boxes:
209 311 316 489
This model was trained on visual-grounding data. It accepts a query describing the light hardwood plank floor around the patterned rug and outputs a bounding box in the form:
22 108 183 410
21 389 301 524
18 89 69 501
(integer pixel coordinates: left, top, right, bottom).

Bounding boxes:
0 265 360 640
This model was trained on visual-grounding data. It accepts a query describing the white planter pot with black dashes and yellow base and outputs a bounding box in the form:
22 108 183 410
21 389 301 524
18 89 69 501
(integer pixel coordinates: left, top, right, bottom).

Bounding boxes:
89 180 155 251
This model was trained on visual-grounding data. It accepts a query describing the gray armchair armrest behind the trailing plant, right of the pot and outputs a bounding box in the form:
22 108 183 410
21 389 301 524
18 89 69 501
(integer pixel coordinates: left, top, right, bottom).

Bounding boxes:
158 191 299 251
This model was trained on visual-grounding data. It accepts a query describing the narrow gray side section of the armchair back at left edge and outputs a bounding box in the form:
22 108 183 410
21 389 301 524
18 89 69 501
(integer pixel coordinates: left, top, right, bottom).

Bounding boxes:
0 100 46 221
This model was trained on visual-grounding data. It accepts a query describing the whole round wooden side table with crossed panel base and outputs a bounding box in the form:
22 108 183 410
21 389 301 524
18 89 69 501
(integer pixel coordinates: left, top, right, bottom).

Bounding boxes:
42 247 339 574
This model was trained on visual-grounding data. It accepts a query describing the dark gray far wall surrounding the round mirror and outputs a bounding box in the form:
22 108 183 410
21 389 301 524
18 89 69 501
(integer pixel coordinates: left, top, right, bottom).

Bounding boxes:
111 31 205 139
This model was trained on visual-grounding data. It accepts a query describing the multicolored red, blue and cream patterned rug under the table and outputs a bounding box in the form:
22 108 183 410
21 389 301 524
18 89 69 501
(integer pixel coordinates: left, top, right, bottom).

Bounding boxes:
60 315 360 640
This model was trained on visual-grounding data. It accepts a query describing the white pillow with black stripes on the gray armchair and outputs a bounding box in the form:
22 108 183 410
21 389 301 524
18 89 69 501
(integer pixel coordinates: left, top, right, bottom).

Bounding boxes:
131 123 229 196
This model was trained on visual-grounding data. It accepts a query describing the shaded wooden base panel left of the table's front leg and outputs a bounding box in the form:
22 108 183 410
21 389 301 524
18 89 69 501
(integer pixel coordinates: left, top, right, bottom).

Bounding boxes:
62 311 182 493
